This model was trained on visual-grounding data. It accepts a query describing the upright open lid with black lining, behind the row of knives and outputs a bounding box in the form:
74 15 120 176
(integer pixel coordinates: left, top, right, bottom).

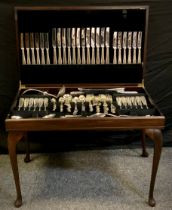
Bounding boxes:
15 6 148 85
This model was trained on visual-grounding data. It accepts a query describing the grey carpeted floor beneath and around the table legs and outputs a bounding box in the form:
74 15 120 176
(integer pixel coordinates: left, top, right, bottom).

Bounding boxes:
0 146 172 210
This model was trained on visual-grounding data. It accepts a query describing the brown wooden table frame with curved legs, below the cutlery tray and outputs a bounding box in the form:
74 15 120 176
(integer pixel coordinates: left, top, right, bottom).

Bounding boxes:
6 116 165 207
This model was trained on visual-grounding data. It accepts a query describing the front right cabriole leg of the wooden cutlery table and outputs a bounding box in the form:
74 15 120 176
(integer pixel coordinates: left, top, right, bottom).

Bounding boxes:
145 129 163 207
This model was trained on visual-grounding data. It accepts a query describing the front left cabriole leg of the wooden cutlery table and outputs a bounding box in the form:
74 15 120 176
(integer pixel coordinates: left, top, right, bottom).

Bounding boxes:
8 132 24 207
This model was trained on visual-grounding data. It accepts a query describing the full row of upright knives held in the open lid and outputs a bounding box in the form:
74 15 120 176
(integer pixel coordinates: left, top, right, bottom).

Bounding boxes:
20 27 142 65
